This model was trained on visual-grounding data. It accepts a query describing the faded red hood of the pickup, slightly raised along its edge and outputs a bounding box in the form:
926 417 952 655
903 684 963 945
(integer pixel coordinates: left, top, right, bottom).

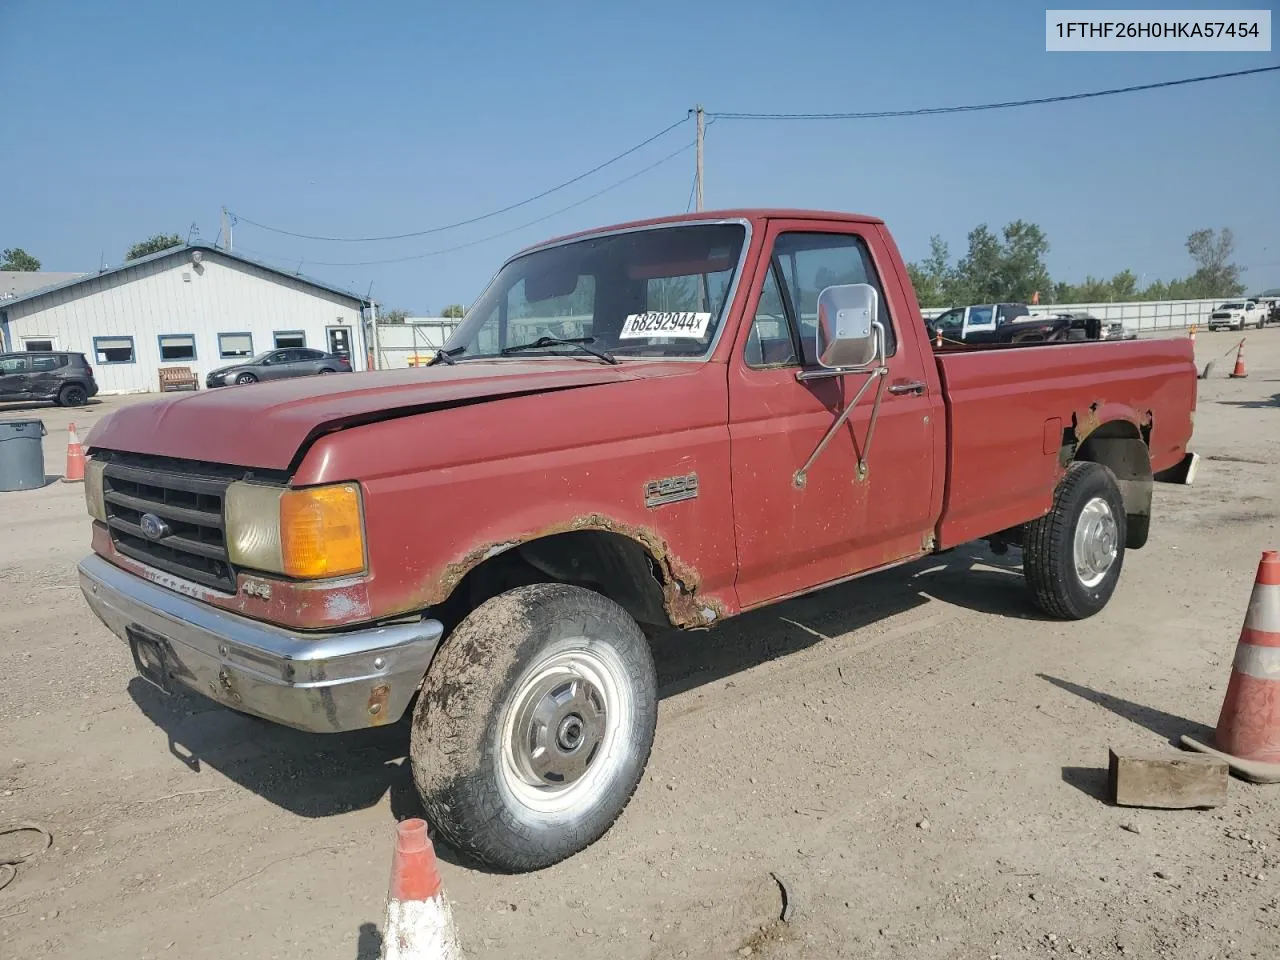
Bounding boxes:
86 358 660 470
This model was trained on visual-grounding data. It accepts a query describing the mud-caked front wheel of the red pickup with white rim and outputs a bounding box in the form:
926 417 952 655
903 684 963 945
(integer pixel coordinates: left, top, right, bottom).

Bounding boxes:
410 584 658 873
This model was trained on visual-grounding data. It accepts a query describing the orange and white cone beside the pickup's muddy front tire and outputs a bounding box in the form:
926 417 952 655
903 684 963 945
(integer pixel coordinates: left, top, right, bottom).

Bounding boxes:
381 819 462 960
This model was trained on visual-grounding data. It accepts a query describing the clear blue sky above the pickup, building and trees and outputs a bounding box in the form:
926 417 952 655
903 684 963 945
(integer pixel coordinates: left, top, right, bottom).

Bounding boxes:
0 0 1280 314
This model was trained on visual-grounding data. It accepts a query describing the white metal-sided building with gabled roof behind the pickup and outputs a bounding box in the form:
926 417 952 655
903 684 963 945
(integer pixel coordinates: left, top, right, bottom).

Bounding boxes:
0 243 370 393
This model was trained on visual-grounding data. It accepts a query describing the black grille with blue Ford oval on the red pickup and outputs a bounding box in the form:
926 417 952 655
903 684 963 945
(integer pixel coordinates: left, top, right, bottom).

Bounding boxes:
102 452 275 593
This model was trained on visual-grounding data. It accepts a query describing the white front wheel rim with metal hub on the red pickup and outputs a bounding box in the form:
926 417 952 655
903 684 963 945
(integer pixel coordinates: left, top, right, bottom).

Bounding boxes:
499 637 634 813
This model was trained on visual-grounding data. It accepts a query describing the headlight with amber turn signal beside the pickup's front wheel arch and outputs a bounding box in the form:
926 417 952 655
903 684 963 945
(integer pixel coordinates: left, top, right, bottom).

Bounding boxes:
225 481 365 580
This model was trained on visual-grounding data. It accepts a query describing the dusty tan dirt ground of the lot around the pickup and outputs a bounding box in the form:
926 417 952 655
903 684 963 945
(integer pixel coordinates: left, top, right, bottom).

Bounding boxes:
0 329 1280 960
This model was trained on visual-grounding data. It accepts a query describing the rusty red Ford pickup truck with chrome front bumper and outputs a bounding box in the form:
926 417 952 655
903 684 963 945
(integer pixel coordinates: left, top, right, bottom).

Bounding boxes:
79 210 1197 870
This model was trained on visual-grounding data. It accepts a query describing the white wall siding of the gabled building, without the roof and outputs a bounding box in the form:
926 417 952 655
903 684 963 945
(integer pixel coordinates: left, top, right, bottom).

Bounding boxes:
0 250 366 393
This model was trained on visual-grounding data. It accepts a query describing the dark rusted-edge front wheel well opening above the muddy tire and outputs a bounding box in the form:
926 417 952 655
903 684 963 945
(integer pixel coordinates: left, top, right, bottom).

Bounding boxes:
438 530 678 640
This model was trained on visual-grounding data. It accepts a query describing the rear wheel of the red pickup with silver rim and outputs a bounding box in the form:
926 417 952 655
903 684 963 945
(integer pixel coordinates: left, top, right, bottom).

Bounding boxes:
1023 461 1128 620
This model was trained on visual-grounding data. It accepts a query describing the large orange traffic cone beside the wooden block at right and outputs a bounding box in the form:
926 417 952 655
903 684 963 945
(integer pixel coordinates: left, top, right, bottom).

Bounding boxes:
1181 550 1280 783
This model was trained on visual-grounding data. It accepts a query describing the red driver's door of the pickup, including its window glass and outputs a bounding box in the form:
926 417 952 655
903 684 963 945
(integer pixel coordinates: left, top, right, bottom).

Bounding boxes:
728 220 943 607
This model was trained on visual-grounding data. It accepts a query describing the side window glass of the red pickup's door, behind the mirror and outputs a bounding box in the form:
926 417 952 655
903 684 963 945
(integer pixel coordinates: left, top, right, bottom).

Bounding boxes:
773 233 897 366
